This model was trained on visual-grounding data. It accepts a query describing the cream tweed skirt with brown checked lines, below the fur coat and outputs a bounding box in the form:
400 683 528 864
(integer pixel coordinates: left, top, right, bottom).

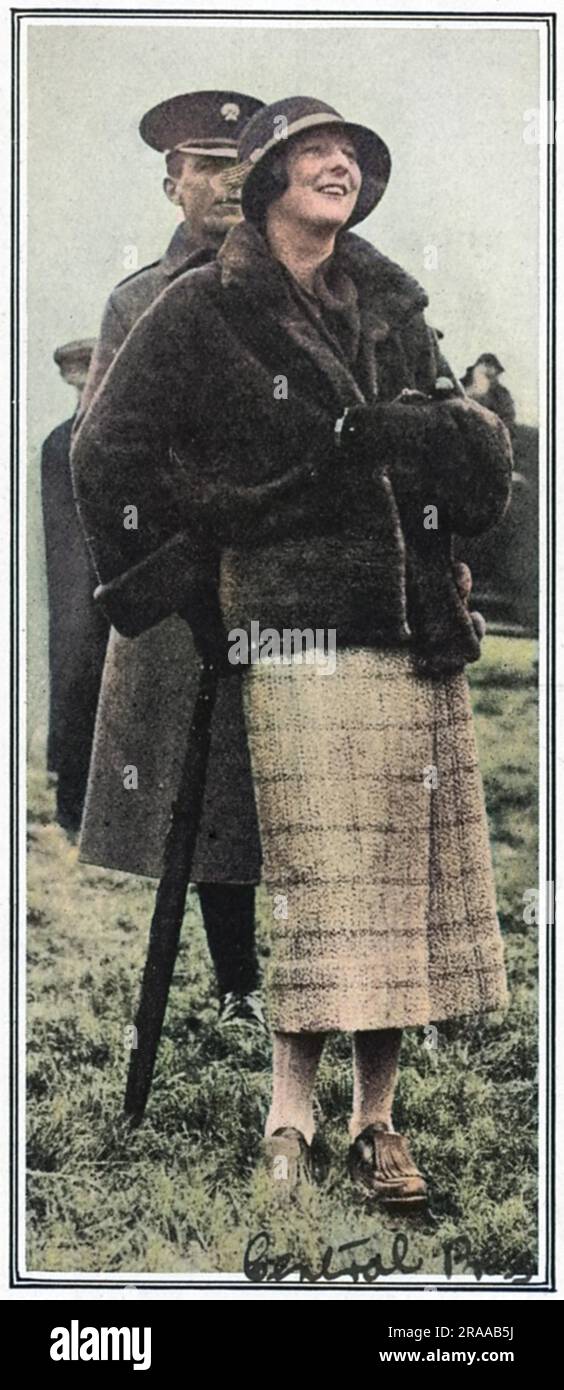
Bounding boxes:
243 648 507 1033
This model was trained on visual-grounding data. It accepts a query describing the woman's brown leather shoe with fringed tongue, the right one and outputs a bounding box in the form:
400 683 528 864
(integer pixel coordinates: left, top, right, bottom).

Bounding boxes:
349 1125 428 1208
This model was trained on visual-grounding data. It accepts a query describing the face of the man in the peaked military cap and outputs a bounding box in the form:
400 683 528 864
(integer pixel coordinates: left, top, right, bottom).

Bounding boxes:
164 154 242 246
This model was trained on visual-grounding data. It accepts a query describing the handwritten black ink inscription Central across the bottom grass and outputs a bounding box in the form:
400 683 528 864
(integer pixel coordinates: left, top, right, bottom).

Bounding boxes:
243 1230 531 1284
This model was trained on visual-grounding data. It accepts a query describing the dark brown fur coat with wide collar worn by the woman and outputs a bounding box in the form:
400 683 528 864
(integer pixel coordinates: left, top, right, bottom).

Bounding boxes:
74 222 511 674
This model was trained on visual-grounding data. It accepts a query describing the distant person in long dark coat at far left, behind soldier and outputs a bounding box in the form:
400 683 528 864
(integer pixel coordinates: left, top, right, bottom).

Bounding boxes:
42 338 108 831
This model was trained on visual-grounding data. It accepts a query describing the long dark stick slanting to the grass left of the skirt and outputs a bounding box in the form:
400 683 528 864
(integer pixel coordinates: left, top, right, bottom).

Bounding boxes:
124 660 218 1125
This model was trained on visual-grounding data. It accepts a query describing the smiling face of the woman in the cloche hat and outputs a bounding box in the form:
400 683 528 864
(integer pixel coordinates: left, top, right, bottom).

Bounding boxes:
275 126 363 231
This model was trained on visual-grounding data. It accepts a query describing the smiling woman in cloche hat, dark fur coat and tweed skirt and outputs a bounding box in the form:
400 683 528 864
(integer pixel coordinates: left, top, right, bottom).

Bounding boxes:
74 97 511 1205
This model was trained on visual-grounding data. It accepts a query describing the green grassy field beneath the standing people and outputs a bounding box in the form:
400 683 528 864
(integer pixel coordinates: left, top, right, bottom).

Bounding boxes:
26 637 538 1284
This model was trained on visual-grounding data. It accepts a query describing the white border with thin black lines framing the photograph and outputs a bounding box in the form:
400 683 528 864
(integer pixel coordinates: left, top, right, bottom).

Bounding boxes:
10 7 557 1297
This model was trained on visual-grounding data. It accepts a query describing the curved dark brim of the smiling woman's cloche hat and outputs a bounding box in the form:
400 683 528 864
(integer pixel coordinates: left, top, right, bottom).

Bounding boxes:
242 111 392 227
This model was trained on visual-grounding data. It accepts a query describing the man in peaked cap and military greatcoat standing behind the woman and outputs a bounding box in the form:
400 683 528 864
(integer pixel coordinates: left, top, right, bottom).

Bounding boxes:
78 92 264 1024
